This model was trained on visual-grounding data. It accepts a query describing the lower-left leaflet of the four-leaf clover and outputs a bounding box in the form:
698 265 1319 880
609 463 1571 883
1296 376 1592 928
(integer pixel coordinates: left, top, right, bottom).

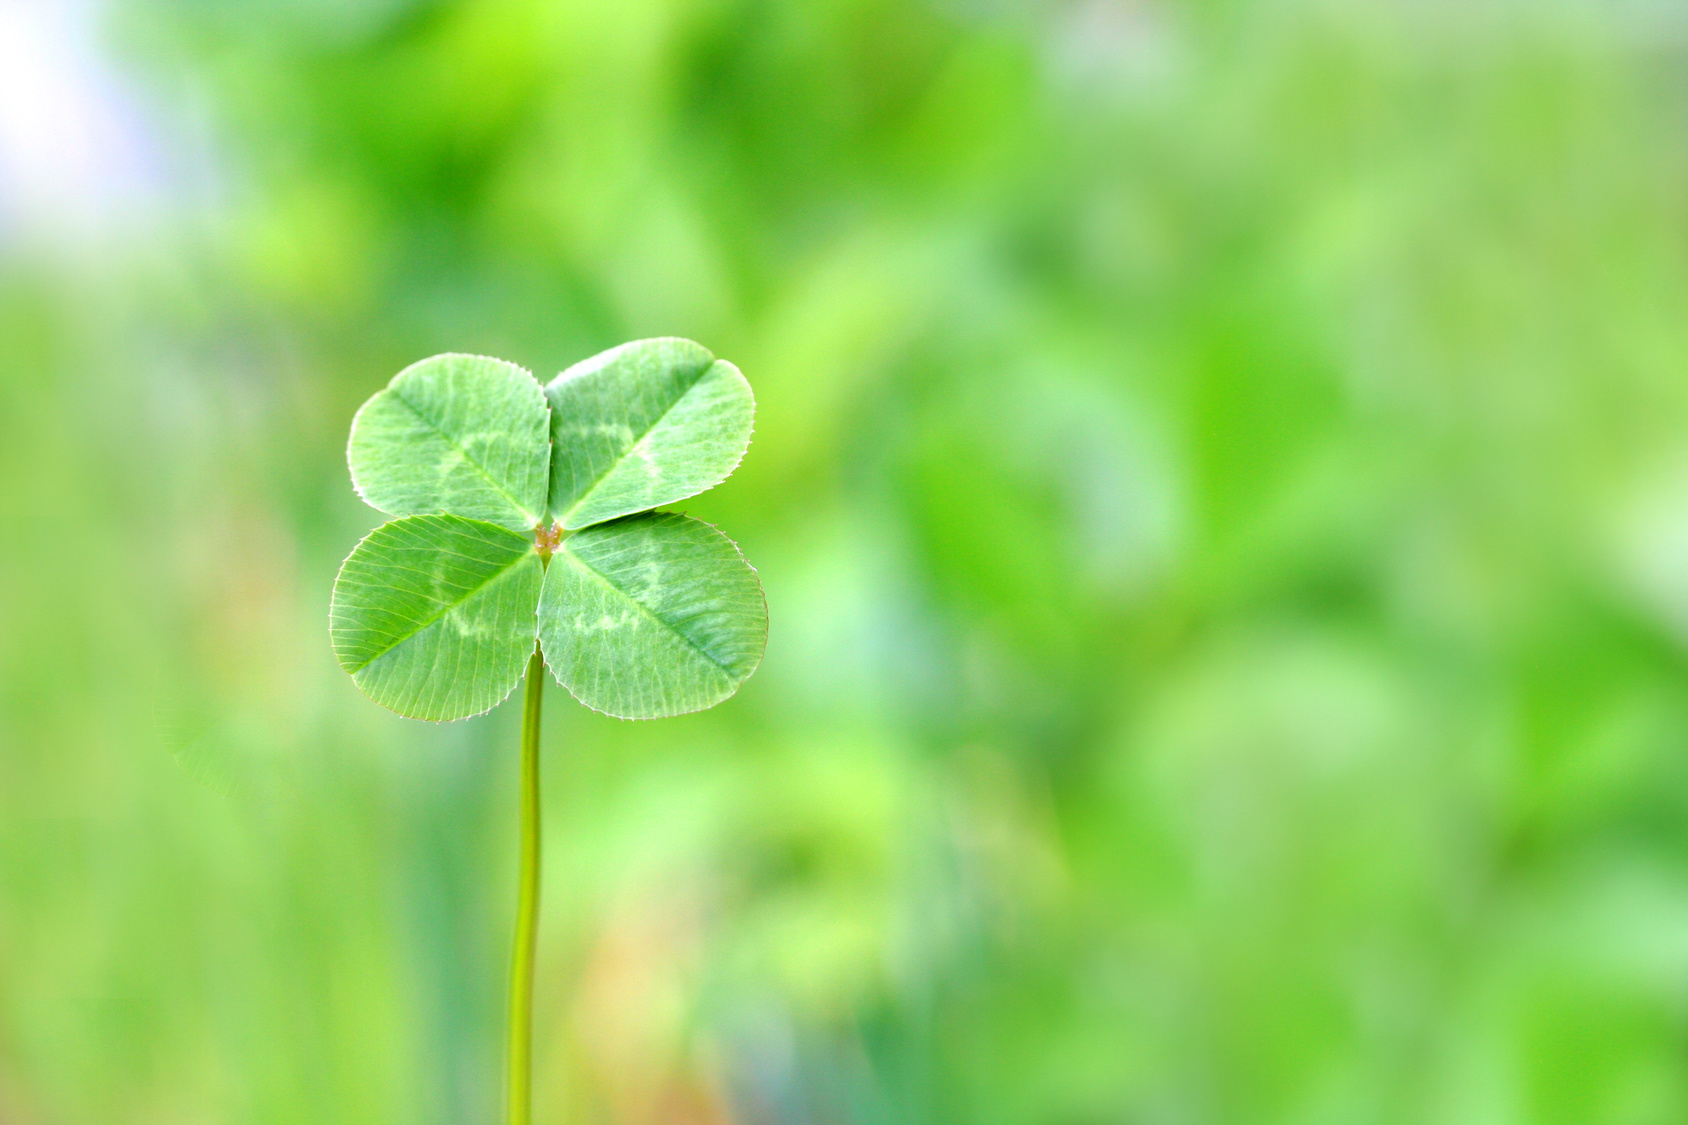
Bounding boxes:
329 515 544 720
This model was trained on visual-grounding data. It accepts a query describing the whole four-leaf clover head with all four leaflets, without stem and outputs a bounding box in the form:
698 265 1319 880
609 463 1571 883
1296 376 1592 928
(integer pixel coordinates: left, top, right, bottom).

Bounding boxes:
329 340 768 720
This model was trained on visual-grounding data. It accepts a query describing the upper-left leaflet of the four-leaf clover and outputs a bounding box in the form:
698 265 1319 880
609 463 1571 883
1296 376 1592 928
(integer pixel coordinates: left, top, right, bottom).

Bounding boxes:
346 355 550 530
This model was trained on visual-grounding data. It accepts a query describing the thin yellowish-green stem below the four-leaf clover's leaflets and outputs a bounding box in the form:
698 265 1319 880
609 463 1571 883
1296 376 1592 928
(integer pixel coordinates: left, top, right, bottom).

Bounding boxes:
510 644 545 1125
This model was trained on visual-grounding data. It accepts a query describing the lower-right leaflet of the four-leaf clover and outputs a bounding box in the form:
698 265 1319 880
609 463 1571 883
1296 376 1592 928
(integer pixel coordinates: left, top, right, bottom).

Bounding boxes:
538 512 768 718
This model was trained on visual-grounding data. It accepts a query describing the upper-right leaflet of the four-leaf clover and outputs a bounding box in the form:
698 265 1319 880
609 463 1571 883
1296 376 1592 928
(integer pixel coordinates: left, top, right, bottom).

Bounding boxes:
545 338 756 529
